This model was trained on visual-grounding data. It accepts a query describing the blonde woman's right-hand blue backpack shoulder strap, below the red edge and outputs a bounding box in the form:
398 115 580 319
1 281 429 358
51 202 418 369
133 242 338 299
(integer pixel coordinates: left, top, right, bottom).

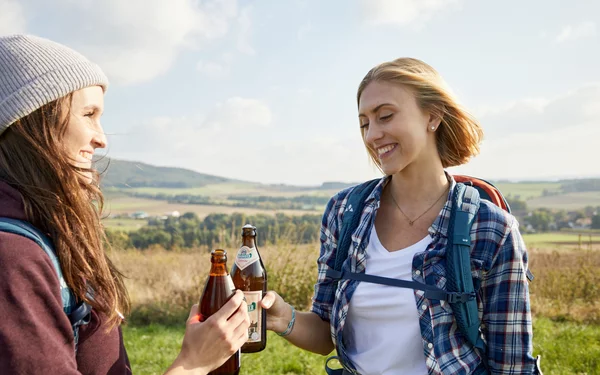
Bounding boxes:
446 183 487 362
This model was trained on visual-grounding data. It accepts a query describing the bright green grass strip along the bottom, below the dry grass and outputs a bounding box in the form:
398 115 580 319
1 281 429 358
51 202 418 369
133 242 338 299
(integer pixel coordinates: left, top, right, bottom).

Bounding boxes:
124 318 600 375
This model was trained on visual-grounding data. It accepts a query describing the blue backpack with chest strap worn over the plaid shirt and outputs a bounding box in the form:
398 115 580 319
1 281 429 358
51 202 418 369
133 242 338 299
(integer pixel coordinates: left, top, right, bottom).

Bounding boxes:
325 176 533 375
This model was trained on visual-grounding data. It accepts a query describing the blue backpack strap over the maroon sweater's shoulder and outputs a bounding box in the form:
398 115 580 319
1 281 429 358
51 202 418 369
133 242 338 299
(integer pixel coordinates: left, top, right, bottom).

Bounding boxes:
0 217 92 352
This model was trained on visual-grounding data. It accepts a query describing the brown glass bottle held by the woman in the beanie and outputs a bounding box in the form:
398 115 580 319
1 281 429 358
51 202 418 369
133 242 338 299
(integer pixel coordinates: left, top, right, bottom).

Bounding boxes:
200 249 240 375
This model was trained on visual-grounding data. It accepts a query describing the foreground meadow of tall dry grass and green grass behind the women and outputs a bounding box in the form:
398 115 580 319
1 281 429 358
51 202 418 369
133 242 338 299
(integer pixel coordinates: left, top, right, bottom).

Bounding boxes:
111 236 600 375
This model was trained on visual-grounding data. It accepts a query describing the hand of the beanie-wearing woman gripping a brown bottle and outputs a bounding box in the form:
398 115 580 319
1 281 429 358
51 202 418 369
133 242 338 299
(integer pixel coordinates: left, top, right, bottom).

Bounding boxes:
165 290 250 375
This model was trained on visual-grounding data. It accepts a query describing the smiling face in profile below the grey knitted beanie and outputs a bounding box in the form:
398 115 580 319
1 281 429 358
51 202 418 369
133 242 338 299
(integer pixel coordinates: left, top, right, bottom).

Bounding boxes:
62 86 106 183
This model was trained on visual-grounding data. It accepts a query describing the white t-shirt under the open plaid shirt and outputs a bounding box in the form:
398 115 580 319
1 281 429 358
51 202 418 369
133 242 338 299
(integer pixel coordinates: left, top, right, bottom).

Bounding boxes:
343 227 431 375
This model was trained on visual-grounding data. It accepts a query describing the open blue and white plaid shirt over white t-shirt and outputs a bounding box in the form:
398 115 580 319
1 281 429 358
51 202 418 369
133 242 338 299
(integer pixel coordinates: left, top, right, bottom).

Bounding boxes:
312 177 535 375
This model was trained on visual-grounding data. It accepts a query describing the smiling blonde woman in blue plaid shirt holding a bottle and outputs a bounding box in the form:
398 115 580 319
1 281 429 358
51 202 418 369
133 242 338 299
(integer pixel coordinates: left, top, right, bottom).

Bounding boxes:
262 58 538 375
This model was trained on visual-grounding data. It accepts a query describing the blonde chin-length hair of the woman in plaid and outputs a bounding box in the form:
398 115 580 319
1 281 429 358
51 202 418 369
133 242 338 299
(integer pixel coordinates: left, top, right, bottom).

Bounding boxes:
356 58 483 169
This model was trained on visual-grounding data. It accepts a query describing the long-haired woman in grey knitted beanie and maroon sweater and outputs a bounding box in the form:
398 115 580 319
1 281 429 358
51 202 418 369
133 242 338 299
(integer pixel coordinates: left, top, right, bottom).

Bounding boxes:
0 35 249 374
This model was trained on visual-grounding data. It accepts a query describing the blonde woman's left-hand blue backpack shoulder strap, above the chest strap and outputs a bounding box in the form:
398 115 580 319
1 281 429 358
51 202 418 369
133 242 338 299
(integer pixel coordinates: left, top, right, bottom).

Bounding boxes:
334 178 381 271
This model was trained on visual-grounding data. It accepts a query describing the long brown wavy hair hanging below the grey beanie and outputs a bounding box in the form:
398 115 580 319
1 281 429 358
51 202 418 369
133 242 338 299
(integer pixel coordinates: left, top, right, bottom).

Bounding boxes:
0 94 130 329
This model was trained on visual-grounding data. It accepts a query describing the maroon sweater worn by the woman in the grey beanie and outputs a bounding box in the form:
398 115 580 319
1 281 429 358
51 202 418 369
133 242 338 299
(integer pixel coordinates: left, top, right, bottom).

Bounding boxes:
0 181 131 375
